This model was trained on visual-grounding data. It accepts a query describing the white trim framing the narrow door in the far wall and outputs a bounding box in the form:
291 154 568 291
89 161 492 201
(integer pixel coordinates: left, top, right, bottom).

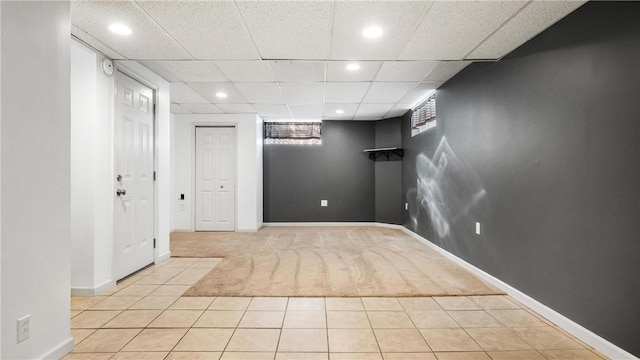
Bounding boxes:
189 121 240 232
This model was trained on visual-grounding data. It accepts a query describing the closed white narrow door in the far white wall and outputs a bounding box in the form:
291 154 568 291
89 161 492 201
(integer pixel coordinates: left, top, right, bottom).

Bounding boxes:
195 127 236 231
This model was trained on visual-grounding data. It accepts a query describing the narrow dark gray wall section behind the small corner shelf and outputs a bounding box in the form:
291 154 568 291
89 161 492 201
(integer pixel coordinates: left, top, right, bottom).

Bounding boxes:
375 118 402 224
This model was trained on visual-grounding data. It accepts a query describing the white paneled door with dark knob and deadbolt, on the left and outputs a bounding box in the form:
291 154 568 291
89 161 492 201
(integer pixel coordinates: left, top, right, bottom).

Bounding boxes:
114 72 154 279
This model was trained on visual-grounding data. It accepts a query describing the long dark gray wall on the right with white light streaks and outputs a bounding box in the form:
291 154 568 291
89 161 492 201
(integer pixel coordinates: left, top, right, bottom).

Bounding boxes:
402 2 640 356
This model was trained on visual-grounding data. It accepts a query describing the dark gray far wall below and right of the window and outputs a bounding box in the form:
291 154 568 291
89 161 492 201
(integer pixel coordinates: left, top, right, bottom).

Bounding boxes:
264 121 375 222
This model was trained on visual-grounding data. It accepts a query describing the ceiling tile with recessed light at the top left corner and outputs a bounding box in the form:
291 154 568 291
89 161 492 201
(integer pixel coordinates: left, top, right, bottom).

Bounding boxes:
71 1 191 60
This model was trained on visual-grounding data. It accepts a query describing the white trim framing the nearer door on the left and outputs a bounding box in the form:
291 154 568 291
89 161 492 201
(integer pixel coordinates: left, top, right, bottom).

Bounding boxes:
111 67 159 283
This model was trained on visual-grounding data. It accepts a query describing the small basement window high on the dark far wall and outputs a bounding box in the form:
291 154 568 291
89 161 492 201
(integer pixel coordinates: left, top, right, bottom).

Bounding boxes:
264 122 322 145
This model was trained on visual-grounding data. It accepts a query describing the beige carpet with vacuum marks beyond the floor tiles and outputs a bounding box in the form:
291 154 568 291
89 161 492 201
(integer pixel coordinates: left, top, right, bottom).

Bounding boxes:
171 227 502 296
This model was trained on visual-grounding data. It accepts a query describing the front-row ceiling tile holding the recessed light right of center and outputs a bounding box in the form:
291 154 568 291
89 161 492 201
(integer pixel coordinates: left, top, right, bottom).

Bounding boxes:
330 1 431 60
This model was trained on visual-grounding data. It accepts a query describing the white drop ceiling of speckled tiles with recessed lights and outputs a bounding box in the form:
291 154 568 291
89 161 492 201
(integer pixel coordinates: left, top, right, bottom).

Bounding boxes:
71 0 585 121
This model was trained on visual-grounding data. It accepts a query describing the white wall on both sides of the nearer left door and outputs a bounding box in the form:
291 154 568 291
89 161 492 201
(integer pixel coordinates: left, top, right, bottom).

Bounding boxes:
71 48 170 296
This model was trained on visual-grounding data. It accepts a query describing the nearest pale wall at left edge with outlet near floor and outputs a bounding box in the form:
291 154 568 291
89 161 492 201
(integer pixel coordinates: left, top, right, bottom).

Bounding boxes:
0 1 73 359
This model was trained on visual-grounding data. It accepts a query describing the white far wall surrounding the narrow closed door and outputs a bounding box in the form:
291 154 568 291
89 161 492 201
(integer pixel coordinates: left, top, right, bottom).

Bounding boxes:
171 114 263 231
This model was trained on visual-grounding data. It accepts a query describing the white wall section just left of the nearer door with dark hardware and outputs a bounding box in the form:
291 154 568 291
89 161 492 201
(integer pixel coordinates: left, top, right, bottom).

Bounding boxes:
71 41 115 296
